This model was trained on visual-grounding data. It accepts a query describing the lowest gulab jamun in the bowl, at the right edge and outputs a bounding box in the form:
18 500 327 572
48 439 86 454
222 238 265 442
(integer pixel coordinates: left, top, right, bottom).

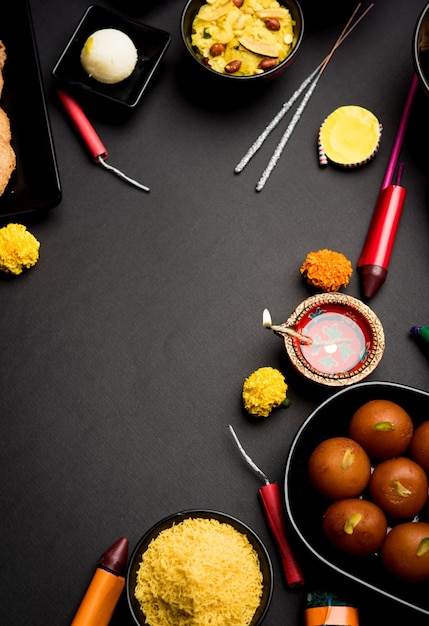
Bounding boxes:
380 522 429 582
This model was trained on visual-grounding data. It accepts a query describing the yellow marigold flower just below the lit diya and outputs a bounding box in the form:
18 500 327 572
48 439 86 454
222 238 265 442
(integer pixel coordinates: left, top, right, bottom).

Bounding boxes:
242 367 290 417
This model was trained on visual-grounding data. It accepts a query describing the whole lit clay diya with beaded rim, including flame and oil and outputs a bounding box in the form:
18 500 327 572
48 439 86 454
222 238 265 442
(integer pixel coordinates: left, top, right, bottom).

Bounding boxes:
264 293 385 386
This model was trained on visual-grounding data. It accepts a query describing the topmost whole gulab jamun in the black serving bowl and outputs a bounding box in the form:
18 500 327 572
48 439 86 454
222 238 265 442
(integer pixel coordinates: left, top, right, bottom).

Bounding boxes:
349 400 414 459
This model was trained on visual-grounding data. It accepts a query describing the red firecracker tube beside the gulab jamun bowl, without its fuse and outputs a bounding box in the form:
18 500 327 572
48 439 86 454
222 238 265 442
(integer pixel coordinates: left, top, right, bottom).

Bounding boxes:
259 483 304 587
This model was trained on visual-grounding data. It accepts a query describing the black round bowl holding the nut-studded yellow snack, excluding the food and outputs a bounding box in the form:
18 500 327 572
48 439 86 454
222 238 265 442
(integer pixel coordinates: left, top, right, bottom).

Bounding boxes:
180 0 304 83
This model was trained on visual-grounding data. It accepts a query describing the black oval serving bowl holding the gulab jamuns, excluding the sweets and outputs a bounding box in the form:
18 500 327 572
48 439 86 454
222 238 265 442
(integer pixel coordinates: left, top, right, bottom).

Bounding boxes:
285 382 429 617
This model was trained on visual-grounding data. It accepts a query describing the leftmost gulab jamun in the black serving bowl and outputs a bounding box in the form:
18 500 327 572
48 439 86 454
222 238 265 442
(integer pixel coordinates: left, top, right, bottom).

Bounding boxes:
308 437 371 500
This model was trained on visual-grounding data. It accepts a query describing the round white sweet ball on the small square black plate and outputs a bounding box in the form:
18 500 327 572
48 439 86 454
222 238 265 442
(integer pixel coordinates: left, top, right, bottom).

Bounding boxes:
80 28 137 84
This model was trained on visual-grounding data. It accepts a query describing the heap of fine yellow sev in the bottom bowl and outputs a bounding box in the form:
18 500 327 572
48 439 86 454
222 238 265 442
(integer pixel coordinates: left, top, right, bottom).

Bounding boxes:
135 518 262 626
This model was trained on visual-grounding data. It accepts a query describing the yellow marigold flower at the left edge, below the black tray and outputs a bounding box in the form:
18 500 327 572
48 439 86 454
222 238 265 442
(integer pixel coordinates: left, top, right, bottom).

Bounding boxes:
0 224 40 274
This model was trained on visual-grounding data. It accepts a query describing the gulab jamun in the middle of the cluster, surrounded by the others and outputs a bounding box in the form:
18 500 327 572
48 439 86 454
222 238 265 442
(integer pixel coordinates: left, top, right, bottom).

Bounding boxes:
369 457 428 519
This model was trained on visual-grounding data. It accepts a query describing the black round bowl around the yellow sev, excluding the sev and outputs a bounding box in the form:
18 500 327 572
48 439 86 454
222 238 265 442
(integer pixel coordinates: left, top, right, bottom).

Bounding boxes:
126 509 273 626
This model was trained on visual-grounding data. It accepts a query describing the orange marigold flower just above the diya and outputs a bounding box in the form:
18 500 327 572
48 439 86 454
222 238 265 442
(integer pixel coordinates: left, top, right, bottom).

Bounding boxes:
300 249 353 291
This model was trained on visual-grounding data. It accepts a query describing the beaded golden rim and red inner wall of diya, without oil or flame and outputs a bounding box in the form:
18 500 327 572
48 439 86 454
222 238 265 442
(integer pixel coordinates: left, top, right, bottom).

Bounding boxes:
273 292 385 387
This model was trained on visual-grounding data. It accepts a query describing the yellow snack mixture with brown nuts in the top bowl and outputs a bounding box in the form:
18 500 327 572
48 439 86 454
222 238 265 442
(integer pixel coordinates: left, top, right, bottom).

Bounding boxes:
192 0 295 76
